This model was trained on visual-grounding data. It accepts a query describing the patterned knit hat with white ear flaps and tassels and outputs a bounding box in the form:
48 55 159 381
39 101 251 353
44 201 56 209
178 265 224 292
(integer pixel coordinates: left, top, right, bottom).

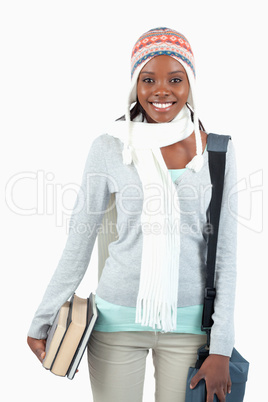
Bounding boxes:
123 28 203 171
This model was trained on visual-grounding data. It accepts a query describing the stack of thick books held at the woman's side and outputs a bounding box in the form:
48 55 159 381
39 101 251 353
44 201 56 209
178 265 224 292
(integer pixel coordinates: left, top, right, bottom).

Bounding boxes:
43 293 98 380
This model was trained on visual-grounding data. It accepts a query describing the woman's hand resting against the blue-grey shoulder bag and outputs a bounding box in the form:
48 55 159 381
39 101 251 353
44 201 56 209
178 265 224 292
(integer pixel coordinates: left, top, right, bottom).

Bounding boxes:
190 354 232 402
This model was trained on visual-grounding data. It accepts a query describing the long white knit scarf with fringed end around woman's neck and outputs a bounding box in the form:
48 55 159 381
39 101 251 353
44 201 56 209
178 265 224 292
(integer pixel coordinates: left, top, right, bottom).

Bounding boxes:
108 106 201 332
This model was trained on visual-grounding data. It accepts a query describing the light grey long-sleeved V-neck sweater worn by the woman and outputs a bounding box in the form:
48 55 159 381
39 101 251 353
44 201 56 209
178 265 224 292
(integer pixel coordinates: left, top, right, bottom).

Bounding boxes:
28 134 237 356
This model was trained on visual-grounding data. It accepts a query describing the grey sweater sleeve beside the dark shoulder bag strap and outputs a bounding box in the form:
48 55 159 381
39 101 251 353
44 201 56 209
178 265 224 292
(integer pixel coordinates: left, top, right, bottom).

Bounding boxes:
210 141 237 356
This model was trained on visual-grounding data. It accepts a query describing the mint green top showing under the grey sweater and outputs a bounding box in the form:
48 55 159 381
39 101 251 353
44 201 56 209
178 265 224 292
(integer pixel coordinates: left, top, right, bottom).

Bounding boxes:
94 168 204 335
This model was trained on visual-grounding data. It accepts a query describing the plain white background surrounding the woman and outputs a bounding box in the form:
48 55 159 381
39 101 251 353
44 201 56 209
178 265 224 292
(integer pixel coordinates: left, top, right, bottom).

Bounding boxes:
0 0 268 402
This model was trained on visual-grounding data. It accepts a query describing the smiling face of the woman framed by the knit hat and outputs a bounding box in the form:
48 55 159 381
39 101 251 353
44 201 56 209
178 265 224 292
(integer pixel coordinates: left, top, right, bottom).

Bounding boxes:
137 55 189 123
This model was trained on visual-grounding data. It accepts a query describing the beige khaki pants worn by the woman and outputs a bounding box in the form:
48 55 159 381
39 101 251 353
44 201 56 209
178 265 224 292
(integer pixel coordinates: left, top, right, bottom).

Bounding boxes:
88 331 206 402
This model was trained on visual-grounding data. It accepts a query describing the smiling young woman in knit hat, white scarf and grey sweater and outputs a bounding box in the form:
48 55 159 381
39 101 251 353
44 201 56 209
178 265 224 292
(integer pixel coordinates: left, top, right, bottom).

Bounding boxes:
28 28 236 402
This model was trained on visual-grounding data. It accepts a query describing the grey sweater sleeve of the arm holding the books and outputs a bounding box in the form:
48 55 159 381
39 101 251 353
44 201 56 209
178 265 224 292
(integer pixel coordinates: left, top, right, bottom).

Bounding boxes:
28 136 110 339
